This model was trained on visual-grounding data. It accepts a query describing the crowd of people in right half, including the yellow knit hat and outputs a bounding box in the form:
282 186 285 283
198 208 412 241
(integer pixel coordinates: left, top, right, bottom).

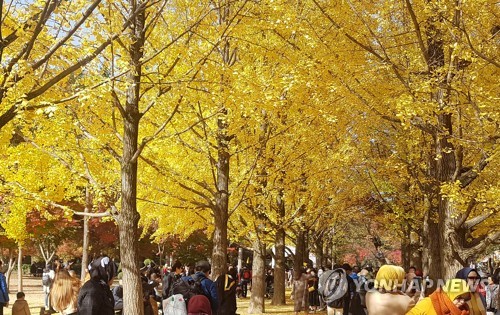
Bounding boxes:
287 264 500 315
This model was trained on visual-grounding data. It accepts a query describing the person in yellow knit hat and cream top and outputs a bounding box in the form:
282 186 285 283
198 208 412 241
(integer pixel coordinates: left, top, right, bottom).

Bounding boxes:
365 265 419 315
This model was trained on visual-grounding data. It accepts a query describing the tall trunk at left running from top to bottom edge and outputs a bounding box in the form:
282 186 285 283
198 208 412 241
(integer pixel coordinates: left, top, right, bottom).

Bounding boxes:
117 0 146 315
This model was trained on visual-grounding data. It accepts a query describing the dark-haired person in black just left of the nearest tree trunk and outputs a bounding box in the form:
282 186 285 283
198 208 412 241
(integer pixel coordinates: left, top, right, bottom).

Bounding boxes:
78 256 117 315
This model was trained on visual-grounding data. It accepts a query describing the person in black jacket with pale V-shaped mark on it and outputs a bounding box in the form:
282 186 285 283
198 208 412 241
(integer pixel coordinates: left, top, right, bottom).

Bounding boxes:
215 266 238 315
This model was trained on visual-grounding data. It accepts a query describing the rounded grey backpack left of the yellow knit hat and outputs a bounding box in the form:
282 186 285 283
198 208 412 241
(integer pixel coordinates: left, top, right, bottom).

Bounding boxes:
318 268 349 308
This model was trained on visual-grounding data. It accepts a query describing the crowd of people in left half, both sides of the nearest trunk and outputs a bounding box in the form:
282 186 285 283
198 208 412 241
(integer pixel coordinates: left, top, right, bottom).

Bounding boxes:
0 256 241 315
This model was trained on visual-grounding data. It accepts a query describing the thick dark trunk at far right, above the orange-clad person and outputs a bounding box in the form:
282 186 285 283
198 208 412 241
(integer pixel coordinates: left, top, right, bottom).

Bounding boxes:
424 4 464 279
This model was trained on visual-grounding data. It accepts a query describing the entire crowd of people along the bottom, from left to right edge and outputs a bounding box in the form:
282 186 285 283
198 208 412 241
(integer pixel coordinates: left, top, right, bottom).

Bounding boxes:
0 256 500 315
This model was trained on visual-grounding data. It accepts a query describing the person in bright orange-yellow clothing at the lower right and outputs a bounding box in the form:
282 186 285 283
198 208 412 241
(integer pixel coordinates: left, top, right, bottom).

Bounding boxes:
406 279 471 315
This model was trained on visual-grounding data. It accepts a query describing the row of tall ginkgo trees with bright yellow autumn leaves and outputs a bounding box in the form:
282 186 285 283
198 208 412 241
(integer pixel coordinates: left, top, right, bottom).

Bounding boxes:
0 0 500 314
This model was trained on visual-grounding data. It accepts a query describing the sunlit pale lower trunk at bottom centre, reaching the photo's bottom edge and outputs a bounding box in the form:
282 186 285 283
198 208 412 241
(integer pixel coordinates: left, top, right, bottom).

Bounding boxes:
248 241 266 314
